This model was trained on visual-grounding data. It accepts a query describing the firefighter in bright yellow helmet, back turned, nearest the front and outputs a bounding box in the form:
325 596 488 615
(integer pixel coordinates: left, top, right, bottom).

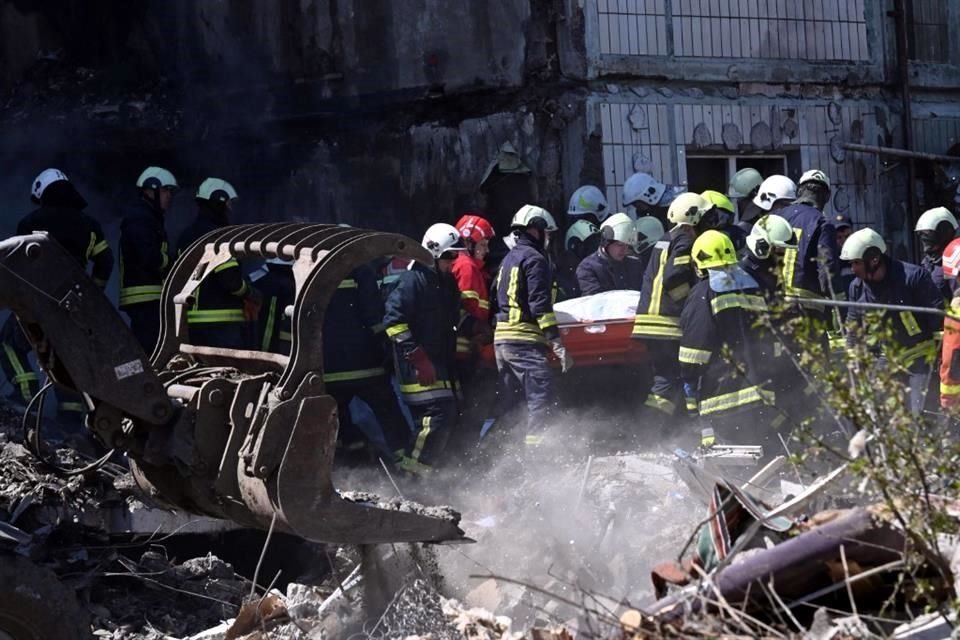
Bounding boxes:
678 229 775 446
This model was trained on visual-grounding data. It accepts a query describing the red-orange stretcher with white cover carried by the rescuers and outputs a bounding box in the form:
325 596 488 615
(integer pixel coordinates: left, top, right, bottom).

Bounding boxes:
481 291 647 368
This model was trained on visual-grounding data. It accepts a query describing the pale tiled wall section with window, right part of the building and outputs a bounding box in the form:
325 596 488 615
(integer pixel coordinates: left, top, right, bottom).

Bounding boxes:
568 0 960 250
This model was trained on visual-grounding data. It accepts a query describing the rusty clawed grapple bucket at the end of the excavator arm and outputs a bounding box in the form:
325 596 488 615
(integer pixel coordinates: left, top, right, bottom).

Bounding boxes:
133 224 464 544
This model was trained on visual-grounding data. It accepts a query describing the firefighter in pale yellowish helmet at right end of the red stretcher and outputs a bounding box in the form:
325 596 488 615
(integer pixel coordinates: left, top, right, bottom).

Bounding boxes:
632 193 710 416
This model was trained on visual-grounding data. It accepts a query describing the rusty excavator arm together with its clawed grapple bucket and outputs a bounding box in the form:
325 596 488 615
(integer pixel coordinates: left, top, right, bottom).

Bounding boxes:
0 224 464 544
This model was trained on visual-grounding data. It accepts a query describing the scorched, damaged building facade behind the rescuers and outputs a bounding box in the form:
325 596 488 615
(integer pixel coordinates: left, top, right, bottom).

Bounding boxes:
0 0 960 251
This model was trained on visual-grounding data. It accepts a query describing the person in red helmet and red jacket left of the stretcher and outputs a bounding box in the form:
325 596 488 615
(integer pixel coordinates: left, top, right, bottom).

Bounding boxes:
451 214 497 385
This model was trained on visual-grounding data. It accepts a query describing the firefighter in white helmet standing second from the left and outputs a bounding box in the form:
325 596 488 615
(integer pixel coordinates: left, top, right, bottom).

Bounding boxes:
119 167 178 354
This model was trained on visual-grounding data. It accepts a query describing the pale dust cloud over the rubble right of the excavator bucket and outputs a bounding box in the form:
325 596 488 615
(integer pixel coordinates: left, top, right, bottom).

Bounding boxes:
337 404 706 623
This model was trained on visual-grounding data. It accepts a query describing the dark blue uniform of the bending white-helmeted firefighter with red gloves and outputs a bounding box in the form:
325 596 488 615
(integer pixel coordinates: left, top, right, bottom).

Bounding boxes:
383 263 460 465
